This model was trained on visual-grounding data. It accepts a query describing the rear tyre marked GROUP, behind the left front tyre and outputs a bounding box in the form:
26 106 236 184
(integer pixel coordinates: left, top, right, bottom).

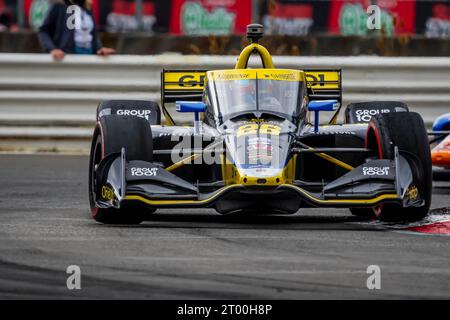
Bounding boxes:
97 100 161 125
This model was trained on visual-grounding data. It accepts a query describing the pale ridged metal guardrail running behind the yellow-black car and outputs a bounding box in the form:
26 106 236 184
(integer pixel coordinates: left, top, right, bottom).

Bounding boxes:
0 53 450 148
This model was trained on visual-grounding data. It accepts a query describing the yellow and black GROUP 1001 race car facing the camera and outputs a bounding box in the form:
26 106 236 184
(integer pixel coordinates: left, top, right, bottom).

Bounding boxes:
89 25 432 224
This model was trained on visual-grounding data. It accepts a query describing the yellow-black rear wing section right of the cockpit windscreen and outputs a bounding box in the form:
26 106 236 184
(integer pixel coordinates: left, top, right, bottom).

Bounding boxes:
303 69 342 124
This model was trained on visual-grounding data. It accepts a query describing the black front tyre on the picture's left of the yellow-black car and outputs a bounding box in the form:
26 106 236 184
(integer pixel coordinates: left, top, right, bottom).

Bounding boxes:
89 115 153 224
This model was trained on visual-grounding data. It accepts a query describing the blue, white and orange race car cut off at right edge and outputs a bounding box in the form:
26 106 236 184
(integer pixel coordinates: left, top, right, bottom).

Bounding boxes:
429 113 450 181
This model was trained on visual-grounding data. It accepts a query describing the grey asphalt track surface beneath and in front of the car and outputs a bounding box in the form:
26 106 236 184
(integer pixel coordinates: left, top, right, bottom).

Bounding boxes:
0 155 450 299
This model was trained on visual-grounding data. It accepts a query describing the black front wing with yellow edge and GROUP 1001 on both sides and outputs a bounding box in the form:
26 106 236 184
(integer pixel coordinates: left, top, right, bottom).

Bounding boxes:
94 149 424 211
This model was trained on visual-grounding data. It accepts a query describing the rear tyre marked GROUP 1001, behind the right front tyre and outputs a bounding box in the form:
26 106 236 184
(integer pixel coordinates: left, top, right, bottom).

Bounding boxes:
345 101 409 123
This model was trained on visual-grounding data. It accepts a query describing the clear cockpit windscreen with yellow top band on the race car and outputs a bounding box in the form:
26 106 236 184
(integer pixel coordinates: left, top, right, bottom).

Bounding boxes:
207 69 305 121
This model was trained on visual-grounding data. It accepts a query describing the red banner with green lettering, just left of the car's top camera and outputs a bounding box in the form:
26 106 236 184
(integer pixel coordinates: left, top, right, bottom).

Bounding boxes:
170 0 252 35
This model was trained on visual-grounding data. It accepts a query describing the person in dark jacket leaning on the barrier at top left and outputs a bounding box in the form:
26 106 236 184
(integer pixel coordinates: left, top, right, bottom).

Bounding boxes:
38 0 115 60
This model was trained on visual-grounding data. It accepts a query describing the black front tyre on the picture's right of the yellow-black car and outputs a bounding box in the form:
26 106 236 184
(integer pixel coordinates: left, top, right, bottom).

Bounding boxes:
366 112 432 221
